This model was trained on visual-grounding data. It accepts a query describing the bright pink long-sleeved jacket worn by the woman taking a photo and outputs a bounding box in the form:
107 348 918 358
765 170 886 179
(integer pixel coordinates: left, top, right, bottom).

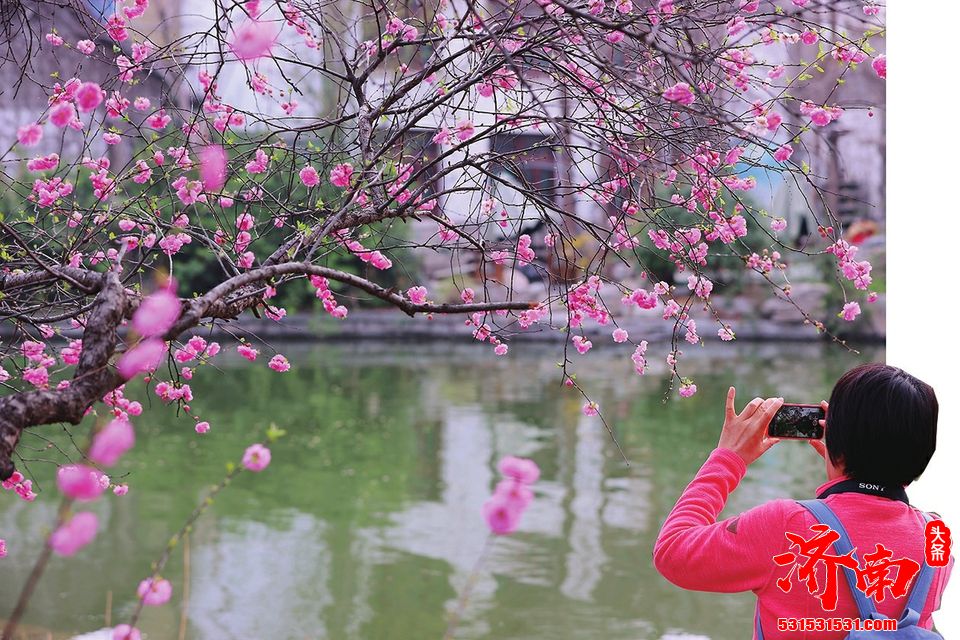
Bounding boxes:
653 448 954 640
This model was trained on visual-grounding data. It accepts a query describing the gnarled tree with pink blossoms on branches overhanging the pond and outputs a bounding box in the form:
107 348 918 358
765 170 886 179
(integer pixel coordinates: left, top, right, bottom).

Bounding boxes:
0 0 886 632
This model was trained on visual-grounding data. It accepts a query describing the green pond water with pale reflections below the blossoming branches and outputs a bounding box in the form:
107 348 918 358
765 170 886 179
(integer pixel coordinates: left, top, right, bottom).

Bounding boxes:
0 342 883 640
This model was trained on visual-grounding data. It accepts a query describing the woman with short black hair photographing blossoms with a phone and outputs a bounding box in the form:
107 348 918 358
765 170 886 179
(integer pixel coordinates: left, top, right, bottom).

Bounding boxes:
653 363 954 640
